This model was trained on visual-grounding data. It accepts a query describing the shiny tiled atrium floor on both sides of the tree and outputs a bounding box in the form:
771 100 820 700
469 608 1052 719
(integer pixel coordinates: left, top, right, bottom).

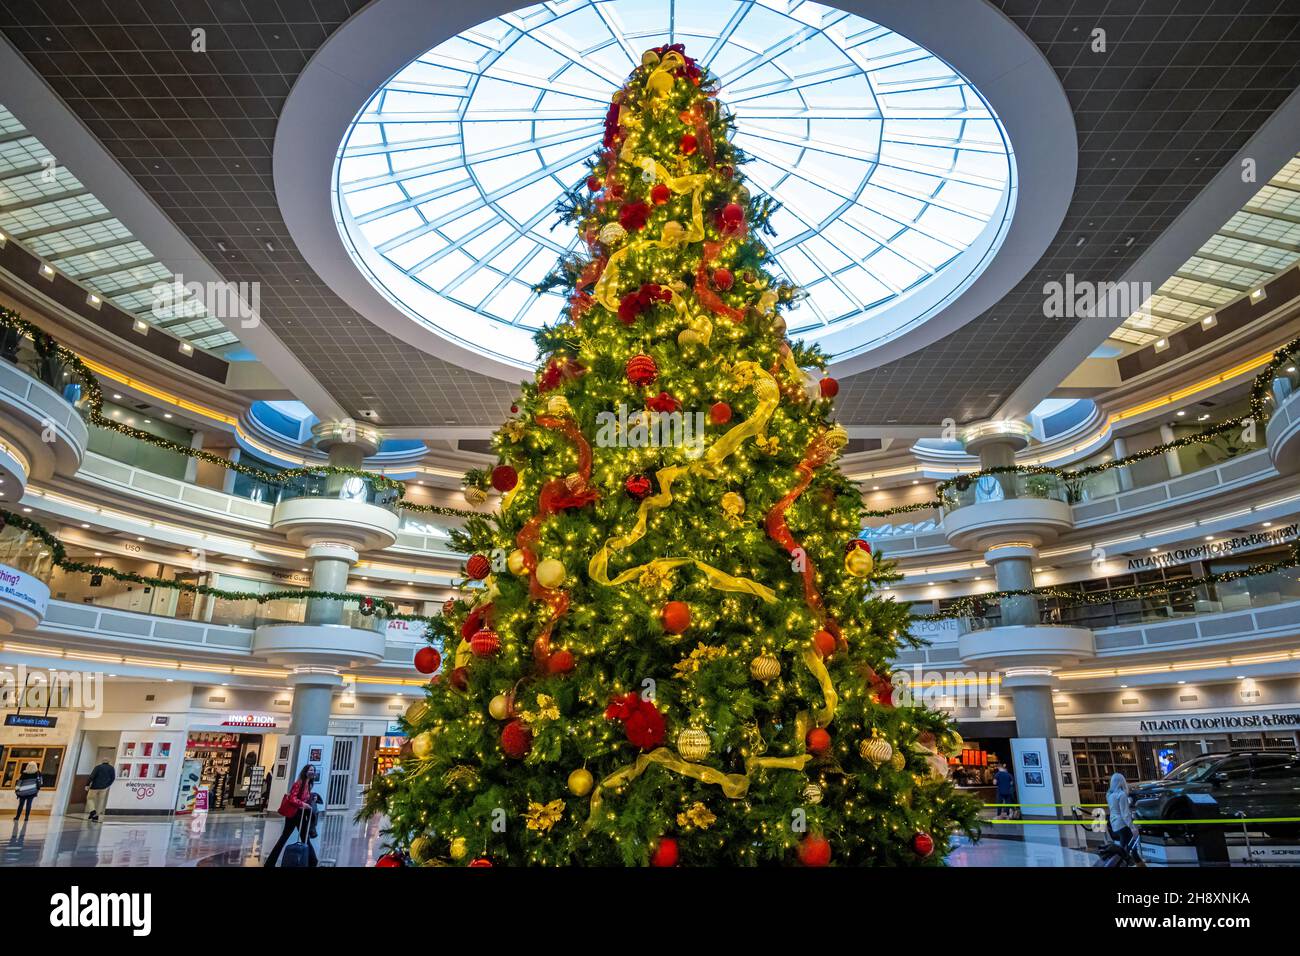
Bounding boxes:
0 812 1096 866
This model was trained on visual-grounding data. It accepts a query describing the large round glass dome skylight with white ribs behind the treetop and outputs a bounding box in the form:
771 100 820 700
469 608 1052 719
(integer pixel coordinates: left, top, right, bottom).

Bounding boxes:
334 0 1015 367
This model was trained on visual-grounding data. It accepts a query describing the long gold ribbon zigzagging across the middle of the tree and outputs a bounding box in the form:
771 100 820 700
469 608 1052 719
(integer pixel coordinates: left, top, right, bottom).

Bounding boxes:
586 362 780 604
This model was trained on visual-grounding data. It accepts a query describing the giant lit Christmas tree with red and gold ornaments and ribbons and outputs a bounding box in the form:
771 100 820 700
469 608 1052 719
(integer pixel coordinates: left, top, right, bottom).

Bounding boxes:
364 46 975 866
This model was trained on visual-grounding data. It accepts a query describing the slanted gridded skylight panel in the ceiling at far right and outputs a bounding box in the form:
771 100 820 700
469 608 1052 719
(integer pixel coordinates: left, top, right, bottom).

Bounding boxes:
1110 156 1300 347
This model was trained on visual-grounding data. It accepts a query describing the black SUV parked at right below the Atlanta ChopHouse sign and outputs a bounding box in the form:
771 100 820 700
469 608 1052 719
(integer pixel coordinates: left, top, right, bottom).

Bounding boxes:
1130 750 1300 836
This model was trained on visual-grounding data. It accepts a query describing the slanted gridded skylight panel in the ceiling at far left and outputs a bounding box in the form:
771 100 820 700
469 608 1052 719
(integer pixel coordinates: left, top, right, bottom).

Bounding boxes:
0 105 238 350
